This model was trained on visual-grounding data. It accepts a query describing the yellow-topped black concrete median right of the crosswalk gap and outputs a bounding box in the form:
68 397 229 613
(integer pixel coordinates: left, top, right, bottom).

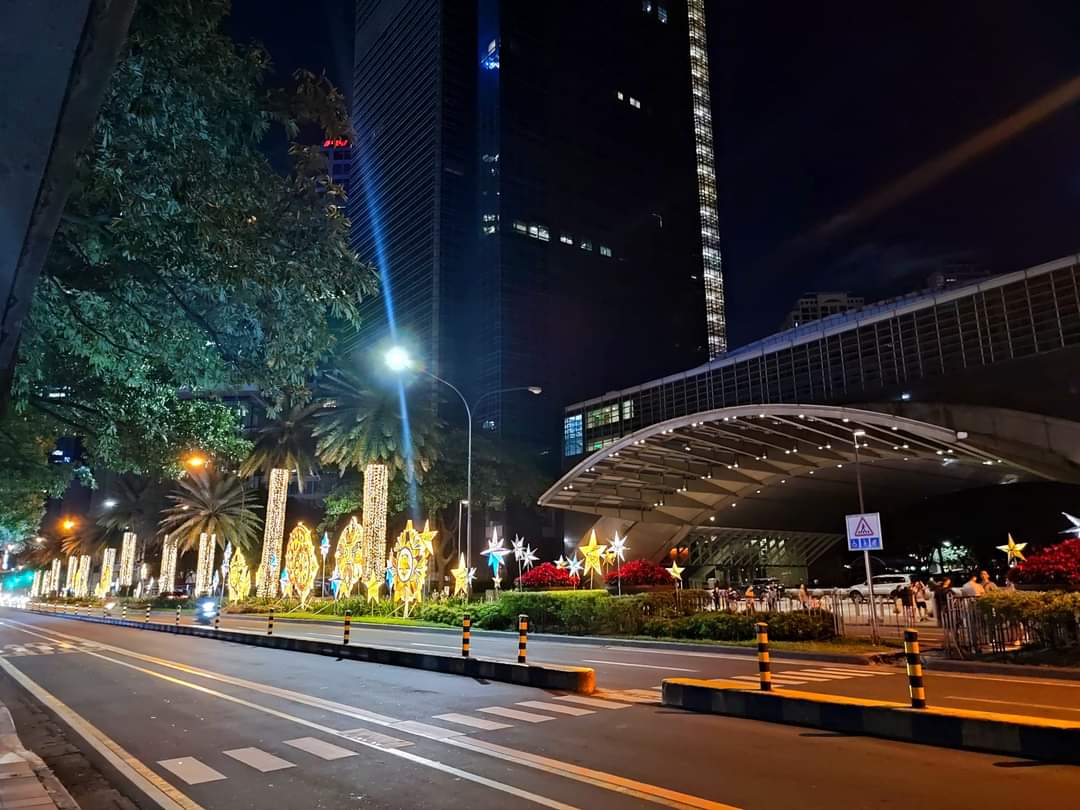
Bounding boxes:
662 678 1080 764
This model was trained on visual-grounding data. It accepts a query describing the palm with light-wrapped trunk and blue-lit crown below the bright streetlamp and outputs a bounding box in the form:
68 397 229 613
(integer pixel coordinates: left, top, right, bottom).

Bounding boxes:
314 372 440 578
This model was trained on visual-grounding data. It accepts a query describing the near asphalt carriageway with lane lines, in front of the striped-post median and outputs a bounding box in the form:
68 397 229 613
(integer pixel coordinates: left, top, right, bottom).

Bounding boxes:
0 610 1080 810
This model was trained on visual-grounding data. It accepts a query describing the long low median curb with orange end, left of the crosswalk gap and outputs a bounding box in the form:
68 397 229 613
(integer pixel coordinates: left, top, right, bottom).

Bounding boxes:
31 610 596 694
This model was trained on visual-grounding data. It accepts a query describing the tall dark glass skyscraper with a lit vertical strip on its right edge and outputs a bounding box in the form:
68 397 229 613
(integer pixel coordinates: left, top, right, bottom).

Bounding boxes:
349 0 726 463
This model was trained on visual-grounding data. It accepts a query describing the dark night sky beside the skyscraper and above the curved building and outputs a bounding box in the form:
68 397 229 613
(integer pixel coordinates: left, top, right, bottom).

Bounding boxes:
233 0 1080 346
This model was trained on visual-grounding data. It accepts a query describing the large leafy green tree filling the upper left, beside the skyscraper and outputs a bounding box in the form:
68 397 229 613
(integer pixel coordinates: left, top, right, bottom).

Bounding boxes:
0 0 376 540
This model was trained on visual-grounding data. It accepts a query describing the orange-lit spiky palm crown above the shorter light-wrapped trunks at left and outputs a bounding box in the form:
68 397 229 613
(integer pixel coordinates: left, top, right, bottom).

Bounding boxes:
160 470 261 553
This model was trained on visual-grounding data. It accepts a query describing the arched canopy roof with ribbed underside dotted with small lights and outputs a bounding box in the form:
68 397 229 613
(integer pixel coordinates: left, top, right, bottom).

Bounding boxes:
540 405 1044 531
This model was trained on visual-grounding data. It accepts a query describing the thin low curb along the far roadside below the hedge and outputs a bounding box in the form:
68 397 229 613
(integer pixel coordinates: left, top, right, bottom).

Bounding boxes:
214 612 889 666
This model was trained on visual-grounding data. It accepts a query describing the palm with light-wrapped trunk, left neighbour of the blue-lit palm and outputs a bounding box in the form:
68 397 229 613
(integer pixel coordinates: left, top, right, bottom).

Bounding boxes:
240 403 321 596
